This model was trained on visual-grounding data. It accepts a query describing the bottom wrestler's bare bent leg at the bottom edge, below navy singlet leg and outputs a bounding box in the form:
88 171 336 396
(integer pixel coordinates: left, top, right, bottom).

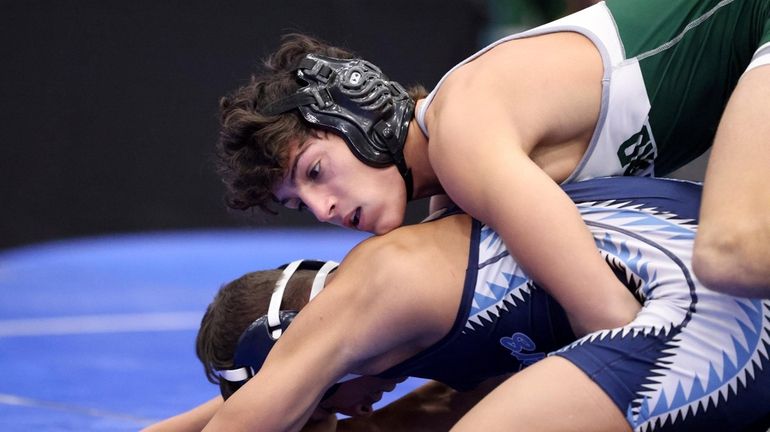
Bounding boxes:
452 357 631 432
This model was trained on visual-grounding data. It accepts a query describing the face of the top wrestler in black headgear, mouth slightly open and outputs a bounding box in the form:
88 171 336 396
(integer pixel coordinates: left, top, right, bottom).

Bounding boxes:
273 131 406 234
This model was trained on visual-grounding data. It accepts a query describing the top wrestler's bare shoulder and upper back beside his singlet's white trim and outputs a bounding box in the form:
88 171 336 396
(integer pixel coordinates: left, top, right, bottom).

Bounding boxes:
426 32 603 153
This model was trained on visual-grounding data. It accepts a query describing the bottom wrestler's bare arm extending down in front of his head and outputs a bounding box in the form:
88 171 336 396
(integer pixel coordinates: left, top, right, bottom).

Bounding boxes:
206 238 450 431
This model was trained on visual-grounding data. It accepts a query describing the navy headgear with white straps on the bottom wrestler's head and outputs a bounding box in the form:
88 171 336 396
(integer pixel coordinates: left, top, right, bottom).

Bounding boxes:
217 260 358 399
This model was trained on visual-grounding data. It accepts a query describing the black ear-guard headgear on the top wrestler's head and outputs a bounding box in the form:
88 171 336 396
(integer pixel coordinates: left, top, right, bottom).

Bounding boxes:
265 54 414 201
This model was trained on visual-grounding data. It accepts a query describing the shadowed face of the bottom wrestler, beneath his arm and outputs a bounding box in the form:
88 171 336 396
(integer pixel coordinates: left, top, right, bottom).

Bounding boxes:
312 376 403 419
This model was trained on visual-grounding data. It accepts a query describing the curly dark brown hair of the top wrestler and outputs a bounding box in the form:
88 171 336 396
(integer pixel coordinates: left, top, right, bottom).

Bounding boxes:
217 33 427 213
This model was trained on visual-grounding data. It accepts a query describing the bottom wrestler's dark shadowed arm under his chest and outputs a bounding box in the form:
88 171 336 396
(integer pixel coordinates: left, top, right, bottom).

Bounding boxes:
337 375 508 432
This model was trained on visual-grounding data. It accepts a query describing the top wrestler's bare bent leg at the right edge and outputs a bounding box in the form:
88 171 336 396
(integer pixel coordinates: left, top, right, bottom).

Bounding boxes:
693 65 770 297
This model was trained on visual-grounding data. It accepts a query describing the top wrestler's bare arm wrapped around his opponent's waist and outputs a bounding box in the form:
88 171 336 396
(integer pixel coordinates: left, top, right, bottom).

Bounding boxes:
429 38 638 334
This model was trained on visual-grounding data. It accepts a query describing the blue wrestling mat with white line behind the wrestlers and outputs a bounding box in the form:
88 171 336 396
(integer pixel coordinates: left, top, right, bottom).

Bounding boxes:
0 229 421 431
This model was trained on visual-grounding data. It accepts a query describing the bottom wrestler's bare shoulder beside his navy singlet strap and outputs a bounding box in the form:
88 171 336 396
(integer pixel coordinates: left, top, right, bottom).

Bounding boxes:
319 215 470 373
